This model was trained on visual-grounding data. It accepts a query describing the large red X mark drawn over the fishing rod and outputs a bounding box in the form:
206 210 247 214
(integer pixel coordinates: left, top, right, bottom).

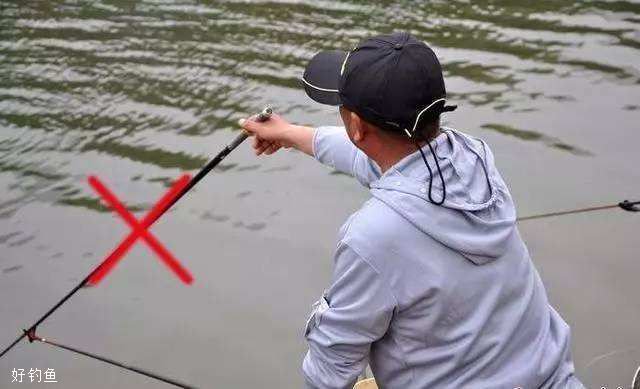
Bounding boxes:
88 174 193 285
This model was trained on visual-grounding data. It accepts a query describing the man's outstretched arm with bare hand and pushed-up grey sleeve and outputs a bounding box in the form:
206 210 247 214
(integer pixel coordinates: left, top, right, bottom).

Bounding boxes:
240 114 381 187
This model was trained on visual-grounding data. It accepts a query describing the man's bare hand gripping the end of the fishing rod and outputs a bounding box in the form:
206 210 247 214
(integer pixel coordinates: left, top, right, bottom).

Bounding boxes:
238 114 292 155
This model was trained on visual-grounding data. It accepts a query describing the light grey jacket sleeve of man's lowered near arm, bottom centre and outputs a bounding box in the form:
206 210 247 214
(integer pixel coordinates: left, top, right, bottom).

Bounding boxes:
302 243 397 389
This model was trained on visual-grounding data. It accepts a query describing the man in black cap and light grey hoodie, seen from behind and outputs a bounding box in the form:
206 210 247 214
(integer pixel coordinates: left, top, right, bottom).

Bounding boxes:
241 32 583 389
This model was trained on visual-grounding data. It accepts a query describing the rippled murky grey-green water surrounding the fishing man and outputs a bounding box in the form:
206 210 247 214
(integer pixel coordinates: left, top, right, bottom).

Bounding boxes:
0 1 640 388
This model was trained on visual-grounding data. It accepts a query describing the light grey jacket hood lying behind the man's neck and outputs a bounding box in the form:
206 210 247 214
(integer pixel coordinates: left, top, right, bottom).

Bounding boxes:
370 128 516 265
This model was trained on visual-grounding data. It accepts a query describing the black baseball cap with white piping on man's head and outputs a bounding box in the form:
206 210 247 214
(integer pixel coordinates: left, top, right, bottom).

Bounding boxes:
302 32 456 137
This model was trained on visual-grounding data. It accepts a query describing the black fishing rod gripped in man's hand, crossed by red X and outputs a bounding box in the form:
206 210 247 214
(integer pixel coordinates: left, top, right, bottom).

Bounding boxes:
0 107 273 382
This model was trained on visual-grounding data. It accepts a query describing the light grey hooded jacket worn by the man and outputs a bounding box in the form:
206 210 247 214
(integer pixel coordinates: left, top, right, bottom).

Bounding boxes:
303 127 582 389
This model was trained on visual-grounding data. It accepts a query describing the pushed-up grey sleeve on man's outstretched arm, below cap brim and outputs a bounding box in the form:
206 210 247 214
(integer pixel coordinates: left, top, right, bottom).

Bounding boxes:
313 126 381 187
